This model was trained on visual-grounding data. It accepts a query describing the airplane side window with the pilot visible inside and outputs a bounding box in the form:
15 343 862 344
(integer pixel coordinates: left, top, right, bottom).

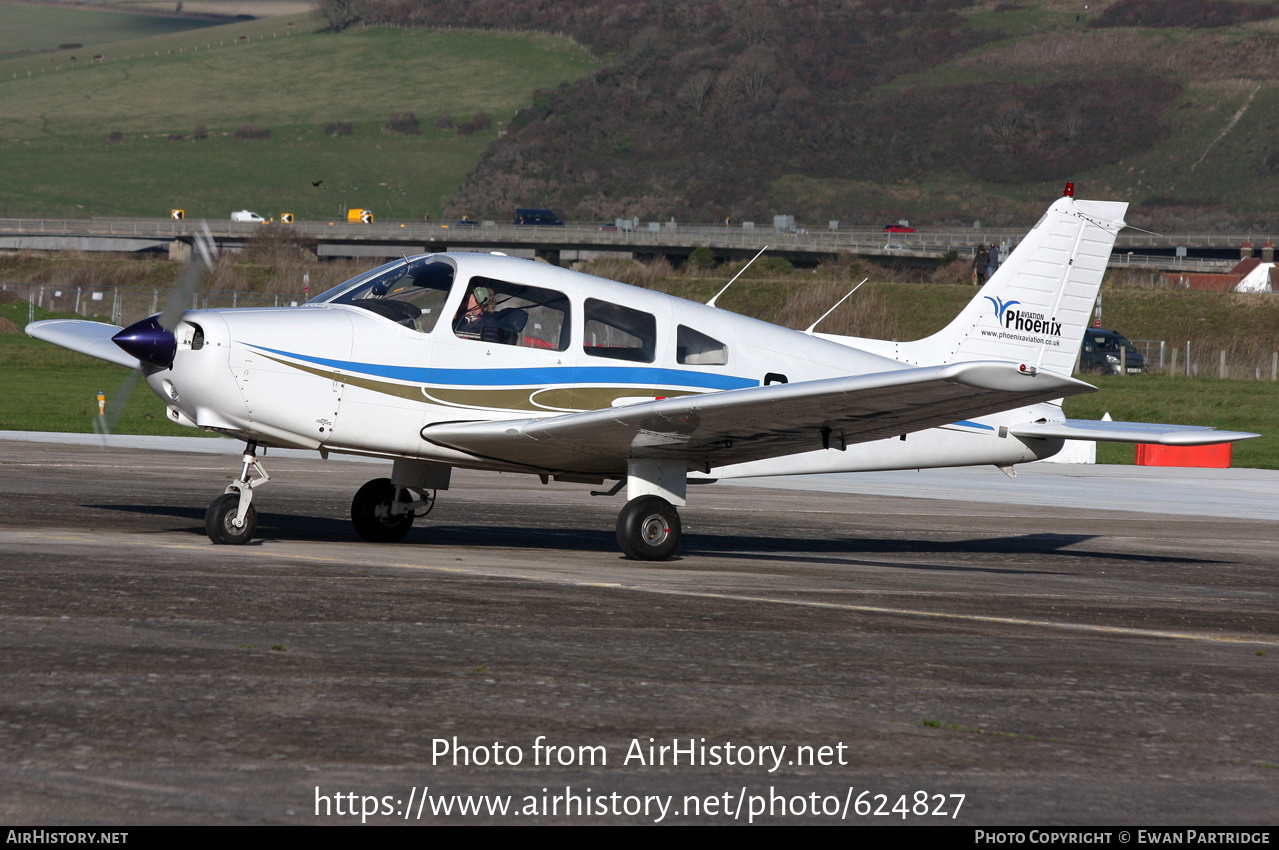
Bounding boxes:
453 277 569 352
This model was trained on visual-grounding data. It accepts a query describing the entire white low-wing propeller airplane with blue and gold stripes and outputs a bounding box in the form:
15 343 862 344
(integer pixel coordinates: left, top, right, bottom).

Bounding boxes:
27 184 1257 560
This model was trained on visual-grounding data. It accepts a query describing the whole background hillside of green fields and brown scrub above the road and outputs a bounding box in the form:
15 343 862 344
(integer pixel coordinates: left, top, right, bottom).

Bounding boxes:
0 0 1279 228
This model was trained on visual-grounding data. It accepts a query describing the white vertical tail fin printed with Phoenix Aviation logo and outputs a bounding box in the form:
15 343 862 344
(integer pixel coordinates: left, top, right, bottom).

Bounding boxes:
822 197 1128 375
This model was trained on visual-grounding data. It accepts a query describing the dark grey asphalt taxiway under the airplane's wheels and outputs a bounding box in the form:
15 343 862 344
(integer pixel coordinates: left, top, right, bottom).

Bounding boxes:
0 433 1279 826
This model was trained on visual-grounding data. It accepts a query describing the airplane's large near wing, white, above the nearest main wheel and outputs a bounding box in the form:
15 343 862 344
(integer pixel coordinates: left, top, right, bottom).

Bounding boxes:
422 362 1096 475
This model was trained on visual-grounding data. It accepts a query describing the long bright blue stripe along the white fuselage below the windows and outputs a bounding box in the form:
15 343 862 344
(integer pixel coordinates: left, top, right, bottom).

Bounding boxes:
252 345 760 390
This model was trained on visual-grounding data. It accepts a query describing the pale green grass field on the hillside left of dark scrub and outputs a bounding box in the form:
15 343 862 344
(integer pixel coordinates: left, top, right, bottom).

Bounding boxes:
0 19 595 220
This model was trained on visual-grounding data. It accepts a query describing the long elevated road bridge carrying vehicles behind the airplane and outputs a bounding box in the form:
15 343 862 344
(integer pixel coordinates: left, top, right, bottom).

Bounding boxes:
0 217 1258 271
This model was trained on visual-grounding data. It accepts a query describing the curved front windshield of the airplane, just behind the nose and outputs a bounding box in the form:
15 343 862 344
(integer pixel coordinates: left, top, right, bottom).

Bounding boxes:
333 258 457 334
